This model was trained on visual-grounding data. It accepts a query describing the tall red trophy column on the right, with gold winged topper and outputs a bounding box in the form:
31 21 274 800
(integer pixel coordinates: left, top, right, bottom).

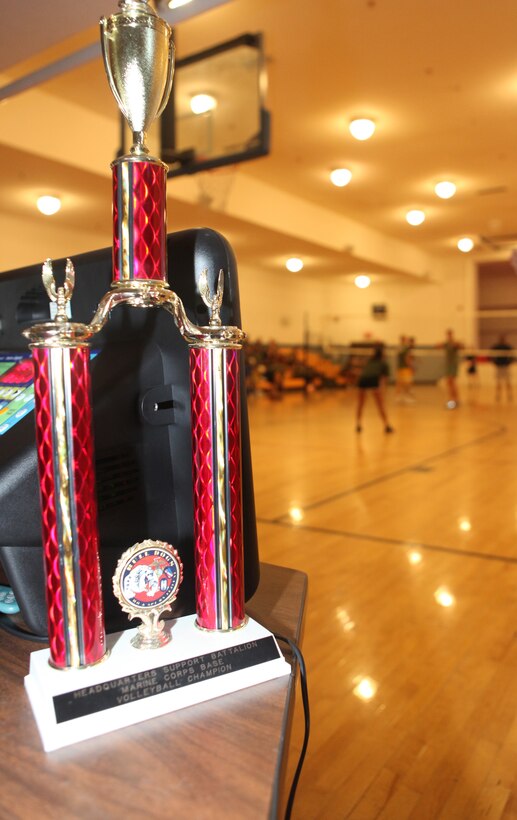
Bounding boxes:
189 277 246 631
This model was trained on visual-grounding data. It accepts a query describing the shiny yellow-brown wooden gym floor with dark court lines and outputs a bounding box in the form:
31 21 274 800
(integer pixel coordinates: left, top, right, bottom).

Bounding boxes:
249 387 517 820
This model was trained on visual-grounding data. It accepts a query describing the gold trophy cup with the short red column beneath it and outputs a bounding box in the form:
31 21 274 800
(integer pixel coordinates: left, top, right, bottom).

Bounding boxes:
100 0 174 291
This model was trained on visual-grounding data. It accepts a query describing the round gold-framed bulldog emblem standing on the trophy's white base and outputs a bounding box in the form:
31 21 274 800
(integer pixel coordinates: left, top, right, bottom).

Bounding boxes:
113 540 183 649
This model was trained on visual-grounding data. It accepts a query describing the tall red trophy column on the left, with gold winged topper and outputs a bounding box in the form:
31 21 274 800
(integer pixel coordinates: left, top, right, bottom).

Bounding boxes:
25 262 106 669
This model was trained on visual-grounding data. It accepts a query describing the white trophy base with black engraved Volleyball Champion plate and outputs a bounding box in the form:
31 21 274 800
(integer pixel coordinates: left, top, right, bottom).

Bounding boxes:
25 615 291 752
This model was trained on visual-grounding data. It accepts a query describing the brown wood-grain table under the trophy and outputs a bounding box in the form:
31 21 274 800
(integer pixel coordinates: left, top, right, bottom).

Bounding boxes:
0 564 307 820
